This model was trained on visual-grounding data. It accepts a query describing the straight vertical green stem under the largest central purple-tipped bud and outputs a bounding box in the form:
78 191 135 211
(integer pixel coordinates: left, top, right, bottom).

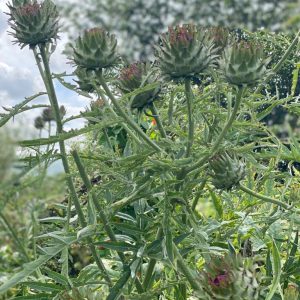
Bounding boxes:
184 78 194 157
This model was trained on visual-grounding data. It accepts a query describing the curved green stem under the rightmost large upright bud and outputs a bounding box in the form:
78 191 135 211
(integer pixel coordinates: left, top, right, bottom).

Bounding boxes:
184 87 245 174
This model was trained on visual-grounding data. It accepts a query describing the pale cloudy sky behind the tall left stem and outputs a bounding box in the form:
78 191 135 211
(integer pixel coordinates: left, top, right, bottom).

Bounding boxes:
0 0 90 138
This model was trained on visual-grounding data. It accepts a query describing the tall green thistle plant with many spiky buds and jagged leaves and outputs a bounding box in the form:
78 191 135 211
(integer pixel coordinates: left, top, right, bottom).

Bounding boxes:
0 0 300 300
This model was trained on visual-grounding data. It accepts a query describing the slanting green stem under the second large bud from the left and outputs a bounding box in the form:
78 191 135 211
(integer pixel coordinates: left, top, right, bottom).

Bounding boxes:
99 74 162 152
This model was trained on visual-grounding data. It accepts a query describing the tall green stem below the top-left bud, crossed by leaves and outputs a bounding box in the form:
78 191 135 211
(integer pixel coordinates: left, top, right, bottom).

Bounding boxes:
39 44 112 286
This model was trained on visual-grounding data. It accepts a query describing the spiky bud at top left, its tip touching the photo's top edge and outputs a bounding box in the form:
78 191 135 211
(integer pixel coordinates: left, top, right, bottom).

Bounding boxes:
8 0 59 48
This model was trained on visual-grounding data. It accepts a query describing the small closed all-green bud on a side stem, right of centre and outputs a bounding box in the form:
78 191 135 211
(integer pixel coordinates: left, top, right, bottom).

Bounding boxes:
209 152 245 190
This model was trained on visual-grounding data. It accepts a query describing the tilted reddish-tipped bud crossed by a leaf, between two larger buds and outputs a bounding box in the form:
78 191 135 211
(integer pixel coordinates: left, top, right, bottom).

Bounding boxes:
119 62 160 109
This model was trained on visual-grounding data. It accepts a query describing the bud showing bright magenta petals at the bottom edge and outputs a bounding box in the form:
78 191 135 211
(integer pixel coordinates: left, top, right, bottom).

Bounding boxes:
199 254 261 300
